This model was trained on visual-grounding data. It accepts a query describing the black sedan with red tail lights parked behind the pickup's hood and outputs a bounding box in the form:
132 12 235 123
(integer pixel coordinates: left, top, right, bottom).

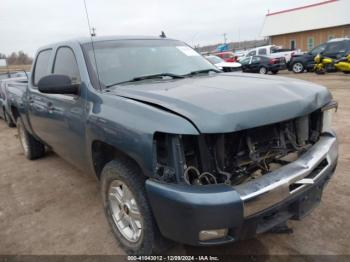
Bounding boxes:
240 56 287 74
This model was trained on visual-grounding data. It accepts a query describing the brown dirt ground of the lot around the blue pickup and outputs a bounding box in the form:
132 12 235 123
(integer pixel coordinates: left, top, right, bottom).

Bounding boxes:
0 72 350 255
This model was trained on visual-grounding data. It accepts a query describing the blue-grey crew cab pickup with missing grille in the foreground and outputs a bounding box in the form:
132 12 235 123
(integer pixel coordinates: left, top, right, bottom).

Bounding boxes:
12 37 338 254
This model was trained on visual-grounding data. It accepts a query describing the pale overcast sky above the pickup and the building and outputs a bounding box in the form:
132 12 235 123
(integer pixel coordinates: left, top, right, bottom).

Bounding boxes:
0 0 322 56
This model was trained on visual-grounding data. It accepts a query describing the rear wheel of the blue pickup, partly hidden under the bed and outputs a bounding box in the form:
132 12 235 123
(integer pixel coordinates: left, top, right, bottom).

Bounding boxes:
17 118 45 160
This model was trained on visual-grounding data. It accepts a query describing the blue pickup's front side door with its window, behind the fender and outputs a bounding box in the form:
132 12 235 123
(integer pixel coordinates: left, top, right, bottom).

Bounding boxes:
45 46 86 166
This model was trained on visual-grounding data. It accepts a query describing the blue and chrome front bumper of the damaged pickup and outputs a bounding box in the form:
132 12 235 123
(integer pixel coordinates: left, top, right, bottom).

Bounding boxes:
146 134 338 245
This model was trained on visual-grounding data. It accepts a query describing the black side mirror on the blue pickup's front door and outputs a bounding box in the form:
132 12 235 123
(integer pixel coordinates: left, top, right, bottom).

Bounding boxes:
38 75 80 95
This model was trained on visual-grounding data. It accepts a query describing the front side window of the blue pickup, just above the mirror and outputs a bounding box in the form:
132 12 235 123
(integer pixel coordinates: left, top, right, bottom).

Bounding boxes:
53 47 80 83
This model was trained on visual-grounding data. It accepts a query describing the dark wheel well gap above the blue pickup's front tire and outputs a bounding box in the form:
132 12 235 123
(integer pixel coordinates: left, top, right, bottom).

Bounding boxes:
91 141 142 179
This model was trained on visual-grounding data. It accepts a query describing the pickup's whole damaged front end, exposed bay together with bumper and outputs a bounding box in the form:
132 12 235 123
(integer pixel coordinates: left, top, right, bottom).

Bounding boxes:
146 103 338 245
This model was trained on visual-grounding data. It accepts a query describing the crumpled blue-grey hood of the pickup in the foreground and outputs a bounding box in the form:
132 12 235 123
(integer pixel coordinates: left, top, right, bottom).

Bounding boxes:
110 73 332 133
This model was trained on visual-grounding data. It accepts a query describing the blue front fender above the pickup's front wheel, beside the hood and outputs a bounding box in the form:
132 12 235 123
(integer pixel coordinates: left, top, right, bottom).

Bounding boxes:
86 94 199 177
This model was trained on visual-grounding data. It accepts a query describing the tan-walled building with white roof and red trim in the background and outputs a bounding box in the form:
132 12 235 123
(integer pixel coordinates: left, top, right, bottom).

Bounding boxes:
262 0 350 51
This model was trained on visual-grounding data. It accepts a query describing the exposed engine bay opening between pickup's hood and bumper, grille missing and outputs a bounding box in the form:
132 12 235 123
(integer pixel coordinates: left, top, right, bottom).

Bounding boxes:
154 111 322 185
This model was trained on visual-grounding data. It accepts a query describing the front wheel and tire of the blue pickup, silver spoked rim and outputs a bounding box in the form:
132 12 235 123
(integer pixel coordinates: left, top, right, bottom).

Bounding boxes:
101 160 166 255
